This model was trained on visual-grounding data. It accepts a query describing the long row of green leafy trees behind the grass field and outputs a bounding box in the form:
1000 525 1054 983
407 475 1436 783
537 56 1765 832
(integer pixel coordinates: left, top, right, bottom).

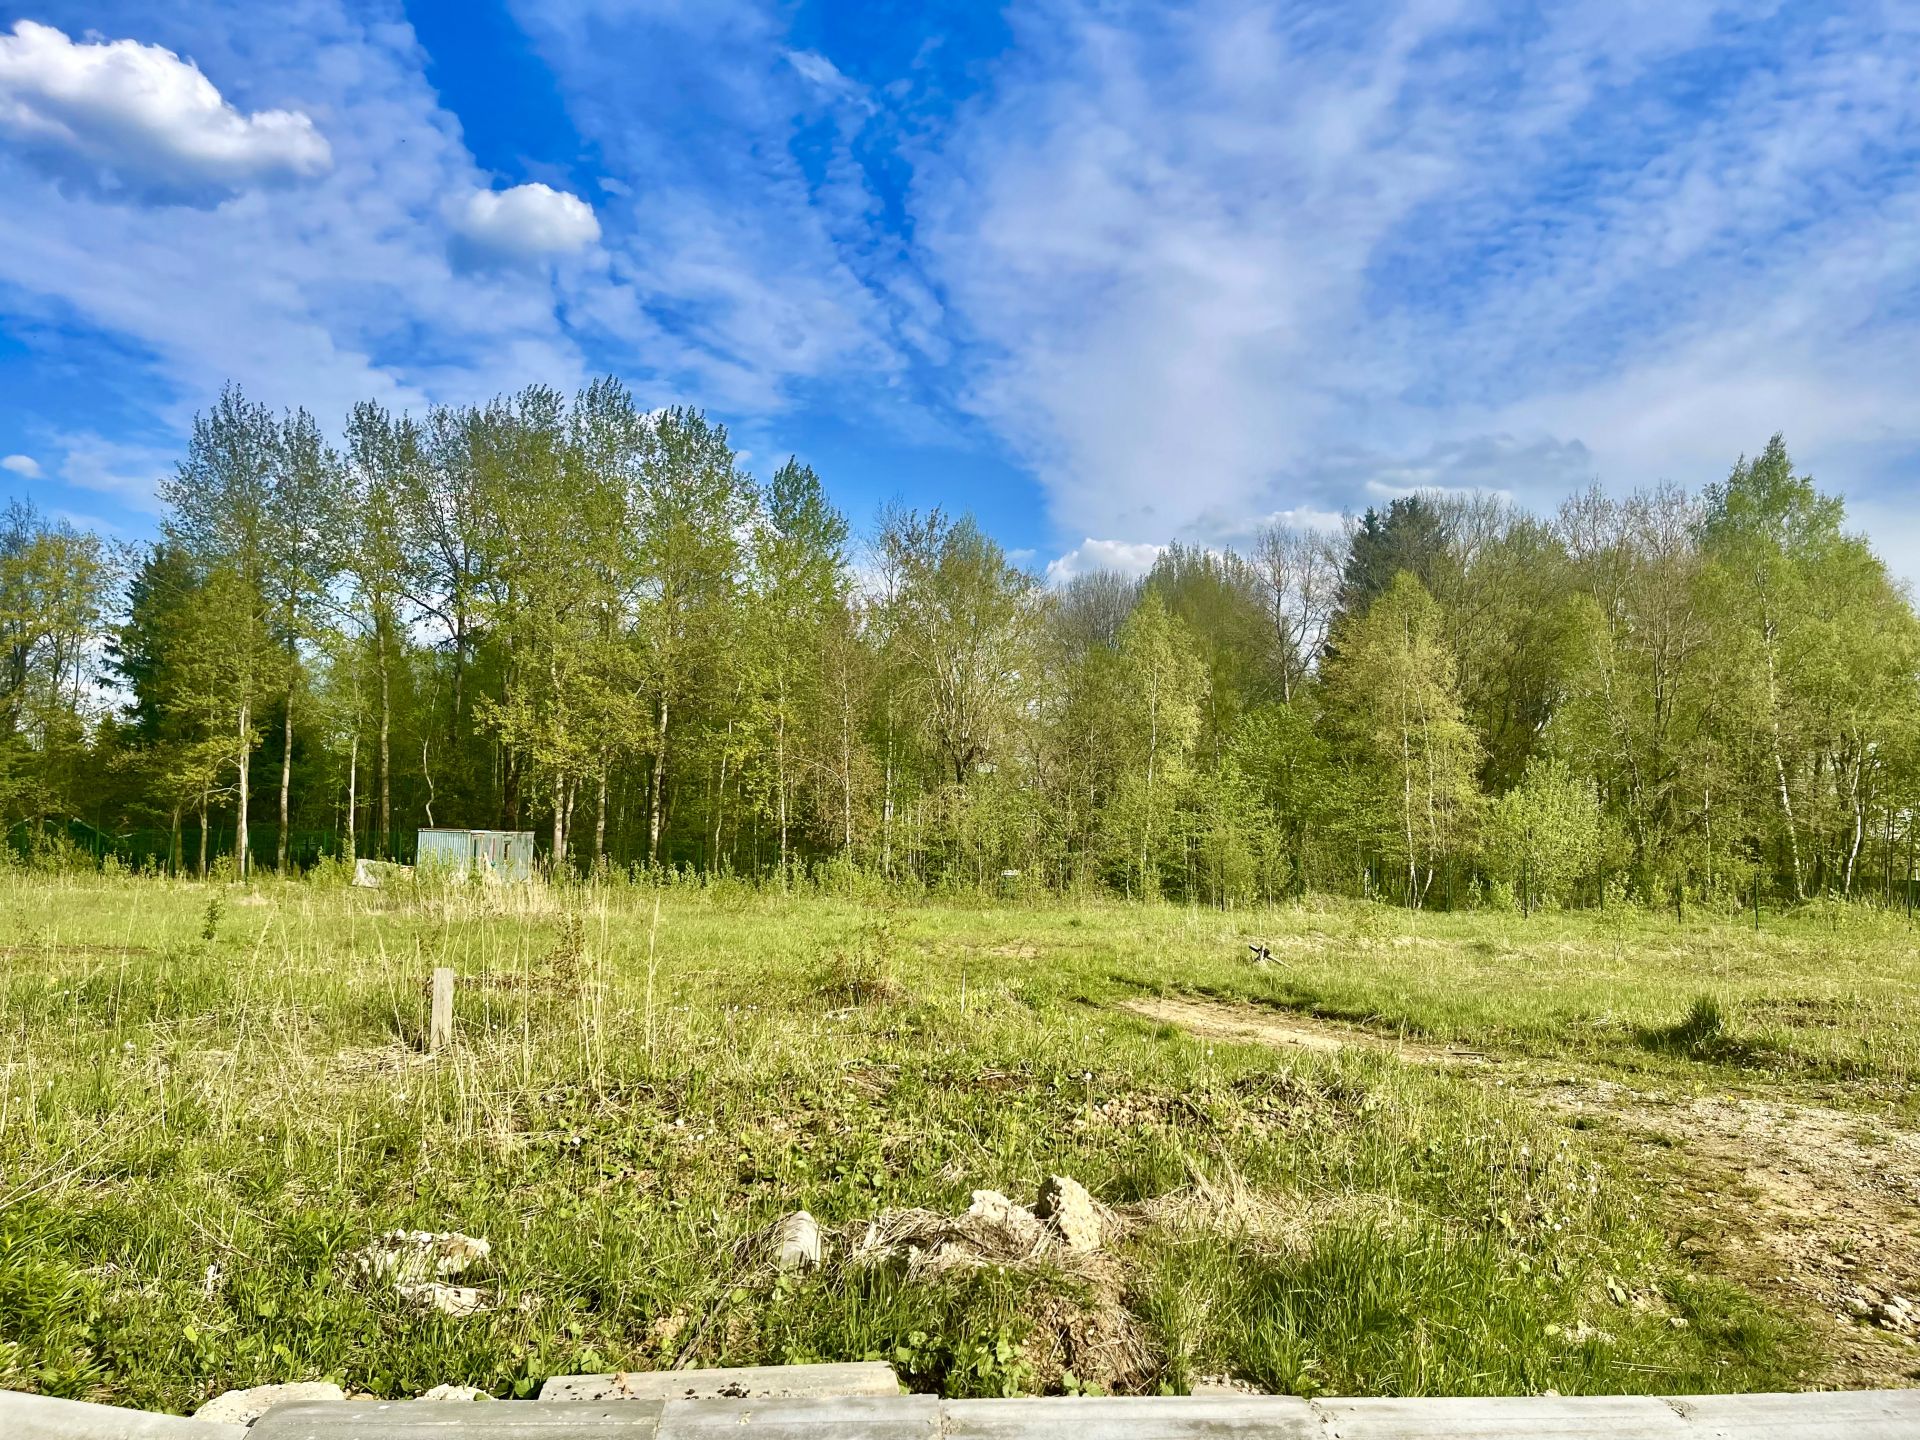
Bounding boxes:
0 380 1920 906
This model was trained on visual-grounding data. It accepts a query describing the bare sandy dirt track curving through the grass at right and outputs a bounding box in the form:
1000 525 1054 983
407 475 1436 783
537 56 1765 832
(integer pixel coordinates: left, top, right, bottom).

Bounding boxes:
1125 996 1920 1388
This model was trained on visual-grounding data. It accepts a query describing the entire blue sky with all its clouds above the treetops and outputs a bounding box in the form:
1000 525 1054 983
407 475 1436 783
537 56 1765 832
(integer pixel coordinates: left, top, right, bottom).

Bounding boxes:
0 0 1920 578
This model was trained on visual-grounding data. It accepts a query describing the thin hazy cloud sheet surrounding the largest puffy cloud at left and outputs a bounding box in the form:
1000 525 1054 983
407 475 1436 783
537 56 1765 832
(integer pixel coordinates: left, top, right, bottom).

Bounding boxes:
0 0 599 443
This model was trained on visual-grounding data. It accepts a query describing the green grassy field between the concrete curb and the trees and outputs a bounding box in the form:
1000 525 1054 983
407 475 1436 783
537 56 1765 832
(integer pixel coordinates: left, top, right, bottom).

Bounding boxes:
0 874 1920 1411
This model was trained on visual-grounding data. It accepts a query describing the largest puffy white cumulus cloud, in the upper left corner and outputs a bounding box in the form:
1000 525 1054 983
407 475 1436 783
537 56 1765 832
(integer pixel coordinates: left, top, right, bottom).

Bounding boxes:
0 19 332 200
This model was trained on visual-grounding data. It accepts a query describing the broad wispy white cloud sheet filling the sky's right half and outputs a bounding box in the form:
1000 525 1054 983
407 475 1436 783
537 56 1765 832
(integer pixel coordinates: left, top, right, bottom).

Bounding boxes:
912 0 1920 556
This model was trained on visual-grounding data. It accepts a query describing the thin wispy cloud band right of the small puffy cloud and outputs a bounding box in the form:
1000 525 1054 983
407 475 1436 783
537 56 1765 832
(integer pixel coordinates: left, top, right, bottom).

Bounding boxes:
511 0 913 417
